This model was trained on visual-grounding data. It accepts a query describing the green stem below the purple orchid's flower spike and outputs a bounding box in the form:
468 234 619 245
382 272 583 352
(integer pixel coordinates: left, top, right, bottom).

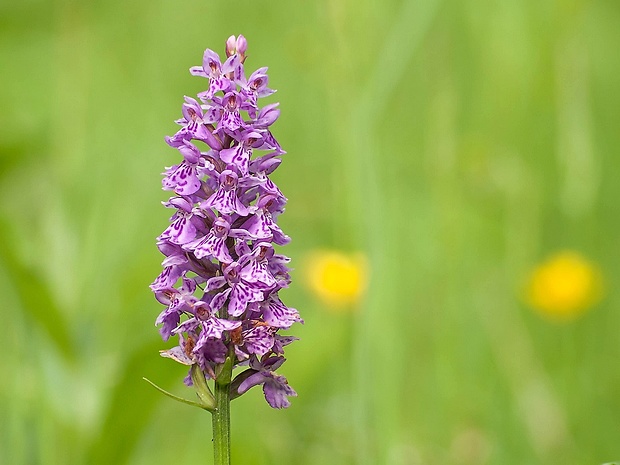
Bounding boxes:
212 355 232 465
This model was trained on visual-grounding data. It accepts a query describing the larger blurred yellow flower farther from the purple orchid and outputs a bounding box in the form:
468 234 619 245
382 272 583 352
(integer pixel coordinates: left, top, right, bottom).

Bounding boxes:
527 251 603 320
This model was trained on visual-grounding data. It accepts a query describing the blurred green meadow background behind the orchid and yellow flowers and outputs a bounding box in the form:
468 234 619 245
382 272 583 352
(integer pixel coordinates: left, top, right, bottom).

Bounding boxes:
0 0 620 465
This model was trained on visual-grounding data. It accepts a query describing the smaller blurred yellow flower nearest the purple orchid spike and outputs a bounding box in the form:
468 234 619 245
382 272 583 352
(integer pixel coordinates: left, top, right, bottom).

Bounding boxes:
305 250 368 307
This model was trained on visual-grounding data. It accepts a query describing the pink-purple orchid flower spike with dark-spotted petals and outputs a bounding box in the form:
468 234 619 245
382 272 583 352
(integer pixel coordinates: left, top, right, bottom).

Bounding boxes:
151 35 302 408
